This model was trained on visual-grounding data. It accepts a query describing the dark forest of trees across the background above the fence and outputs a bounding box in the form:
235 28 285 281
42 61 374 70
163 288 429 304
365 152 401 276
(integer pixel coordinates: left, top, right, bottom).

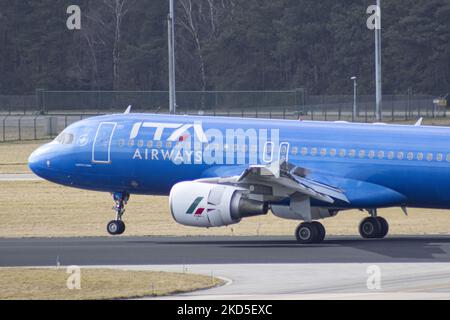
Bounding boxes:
0 0 450 94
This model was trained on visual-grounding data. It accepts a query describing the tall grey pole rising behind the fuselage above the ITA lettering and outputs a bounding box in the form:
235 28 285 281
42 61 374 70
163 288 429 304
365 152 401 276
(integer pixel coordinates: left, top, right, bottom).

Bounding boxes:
167 0 177 114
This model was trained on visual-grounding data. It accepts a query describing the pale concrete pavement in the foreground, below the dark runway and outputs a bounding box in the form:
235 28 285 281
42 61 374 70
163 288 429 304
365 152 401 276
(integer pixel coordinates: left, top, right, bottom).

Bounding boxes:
142 263 450 300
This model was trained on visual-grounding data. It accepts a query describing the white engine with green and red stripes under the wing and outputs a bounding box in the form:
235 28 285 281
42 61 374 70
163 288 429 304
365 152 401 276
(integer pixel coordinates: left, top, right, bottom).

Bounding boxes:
169 181 269 228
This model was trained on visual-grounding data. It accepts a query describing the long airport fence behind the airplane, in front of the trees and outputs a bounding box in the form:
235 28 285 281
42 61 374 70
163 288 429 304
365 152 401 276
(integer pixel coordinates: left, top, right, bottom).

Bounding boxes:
0 89 447 142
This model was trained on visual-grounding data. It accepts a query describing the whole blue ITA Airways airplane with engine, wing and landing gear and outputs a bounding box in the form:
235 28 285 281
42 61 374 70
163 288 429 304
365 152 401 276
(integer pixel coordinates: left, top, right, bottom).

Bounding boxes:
29 110 450 244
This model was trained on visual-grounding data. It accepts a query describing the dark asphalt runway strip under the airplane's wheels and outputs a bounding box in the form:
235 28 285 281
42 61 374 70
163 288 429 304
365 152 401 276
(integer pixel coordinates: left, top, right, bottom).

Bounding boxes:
0 236 450 267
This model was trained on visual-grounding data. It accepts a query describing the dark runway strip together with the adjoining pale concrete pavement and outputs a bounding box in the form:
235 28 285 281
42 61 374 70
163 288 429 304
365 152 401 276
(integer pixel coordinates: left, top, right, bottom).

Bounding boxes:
0 236 450 300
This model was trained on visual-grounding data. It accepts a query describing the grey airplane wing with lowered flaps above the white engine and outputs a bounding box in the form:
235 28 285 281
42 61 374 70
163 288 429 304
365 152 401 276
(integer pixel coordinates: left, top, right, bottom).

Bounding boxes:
198 161 349 204
